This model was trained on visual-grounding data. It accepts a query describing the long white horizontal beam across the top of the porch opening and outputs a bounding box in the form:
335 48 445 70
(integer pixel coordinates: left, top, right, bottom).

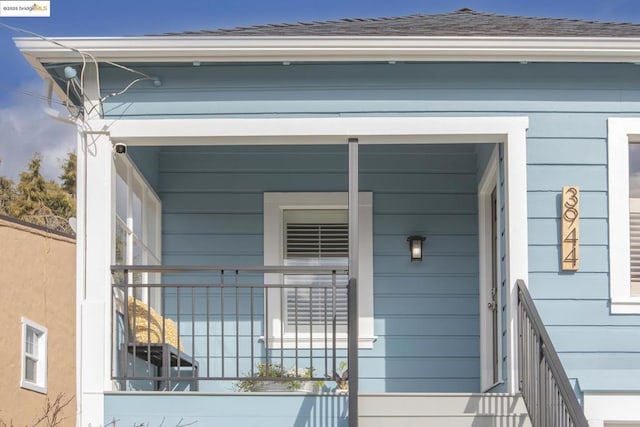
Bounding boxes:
88 117 529 146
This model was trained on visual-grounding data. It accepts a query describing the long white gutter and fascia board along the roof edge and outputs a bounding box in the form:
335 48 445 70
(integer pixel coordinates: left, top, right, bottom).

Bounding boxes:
15 36 640 63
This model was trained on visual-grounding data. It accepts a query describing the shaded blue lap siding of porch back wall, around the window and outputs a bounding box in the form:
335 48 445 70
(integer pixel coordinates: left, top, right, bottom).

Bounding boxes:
159 145 479 392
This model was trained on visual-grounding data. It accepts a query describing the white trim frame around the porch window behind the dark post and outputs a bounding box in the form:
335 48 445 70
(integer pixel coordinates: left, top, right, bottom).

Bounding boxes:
263 192 376 349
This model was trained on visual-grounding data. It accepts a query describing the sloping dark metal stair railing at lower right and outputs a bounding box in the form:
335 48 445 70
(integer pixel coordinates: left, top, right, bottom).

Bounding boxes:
517 280 589 427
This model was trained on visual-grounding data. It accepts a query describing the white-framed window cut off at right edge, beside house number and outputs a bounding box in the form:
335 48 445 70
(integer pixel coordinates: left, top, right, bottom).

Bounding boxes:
608 118 640 313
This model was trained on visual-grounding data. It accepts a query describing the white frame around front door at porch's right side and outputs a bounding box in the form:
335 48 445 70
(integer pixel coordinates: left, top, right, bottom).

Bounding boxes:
478 145 504 392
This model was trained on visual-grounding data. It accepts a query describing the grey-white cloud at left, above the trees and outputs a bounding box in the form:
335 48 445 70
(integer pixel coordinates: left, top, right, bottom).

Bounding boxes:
0 82 76 181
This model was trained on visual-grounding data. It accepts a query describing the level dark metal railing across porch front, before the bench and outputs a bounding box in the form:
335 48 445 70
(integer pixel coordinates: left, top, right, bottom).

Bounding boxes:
111 265 348 391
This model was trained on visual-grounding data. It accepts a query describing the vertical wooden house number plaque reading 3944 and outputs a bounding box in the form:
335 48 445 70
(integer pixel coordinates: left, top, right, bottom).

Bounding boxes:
561 186 580 271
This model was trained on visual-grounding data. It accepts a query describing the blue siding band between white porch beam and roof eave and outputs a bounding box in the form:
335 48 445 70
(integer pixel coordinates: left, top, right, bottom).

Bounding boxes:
100 63 639 118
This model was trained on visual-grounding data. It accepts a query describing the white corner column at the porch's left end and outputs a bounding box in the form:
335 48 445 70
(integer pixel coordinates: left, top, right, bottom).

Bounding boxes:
76 65 115 427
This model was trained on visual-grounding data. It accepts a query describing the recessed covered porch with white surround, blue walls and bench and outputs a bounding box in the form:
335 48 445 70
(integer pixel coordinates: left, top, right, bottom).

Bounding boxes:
80 118 526 426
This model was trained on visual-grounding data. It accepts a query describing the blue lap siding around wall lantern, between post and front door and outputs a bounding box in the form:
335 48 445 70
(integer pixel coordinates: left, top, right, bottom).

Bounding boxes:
360 142 479 400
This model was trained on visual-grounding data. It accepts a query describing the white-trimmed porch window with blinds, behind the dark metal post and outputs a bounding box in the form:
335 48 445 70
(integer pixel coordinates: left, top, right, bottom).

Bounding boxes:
264 193 375 348
